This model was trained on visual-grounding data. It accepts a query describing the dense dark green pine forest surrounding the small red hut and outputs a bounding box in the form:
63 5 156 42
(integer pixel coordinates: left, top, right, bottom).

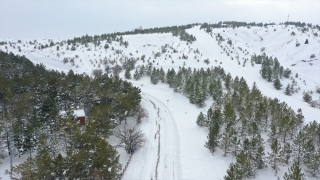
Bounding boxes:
0 51 141 179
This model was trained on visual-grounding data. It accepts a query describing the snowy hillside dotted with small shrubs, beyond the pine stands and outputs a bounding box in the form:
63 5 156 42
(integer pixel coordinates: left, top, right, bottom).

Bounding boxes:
0 25 320 121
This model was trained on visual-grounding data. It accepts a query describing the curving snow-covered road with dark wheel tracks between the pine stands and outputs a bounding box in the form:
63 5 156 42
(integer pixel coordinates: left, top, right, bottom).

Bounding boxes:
123 93 182 179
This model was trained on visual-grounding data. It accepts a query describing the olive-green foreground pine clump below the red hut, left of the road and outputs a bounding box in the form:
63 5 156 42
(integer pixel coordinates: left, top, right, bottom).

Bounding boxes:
11 122 121 179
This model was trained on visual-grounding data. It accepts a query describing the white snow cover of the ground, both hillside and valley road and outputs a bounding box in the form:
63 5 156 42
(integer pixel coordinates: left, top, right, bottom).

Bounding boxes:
0 25 320 180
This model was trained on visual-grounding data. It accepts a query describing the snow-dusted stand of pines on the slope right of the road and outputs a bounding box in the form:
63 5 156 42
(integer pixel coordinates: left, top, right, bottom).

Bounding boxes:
129 61 320 180
